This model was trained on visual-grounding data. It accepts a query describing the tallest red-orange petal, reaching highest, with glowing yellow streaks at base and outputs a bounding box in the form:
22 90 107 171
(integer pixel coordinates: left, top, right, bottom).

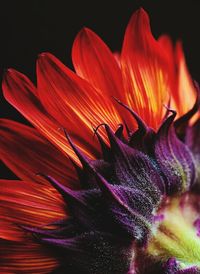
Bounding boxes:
122 9 174 129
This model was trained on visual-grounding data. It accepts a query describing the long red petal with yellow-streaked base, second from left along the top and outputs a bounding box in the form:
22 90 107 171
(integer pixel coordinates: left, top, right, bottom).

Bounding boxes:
37 53 121 143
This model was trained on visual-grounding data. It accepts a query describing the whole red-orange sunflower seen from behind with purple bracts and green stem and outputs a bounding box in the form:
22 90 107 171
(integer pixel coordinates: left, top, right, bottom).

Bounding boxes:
0 9 200 274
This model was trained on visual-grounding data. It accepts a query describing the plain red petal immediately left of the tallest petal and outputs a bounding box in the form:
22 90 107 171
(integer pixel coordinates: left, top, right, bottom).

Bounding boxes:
72 28 124 103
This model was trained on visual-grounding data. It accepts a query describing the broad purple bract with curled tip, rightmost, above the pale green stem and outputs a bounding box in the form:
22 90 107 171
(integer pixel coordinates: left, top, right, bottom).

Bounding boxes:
155 112 195 194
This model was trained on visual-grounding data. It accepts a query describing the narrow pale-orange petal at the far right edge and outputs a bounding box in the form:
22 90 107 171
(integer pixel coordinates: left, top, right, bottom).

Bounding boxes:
172 42 197 116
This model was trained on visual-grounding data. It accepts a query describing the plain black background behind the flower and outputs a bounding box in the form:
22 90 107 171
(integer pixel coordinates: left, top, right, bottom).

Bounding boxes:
0 0 200 178
